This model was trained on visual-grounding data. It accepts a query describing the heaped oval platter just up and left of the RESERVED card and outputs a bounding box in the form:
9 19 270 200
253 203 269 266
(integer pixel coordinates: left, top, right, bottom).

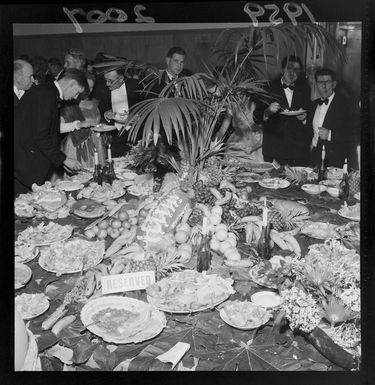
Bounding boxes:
39 238 105 274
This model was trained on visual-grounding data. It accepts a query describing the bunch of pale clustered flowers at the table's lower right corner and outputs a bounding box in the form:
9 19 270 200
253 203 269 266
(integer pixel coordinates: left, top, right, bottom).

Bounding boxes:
280 240 361 356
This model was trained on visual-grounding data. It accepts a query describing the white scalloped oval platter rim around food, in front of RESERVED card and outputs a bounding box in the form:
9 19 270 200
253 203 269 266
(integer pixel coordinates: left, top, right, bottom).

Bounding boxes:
81 295 166 344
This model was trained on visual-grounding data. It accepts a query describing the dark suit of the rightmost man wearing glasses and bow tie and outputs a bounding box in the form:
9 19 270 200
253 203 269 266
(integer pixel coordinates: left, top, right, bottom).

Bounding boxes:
307 92 359 168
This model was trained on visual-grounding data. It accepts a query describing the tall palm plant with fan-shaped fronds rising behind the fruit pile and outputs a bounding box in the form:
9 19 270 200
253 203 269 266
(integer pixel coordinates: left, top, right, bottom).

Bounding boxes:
94 23 345 183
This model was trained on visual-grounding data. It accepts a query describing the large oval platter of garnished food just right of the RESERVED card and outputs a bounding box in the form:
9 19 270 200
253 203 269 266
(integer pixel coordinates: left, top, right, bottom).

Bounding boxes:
146 270 235 314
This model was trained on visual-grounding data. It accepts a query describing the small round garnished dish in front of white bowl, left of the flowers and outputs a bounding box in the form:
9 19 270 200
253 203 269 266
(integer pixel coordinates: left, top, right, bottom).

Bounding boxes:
220 300 271 330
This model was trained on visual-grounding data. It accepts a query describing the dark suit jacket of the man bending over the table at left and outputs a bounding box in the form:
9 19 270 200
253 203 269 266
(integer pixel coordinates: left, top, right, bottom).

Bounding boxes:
14 83 66 187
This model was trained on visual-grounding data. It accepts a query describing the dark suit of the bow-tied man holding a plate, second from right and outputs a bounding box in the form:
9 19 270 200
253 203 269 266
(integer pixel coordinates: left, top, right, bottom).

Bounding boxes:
254 78 313 166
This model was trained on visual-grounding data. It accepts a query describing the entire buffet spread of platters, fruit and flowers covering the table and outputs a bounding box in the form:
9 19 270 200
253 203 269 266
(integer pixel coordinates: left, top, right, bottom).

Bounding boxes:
15 158 361 371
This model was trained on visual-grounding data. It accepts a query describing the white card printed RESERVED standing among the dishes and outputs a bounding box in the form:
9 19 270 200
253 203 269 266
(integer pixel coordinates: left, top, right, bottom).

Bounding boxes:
101 271 155 294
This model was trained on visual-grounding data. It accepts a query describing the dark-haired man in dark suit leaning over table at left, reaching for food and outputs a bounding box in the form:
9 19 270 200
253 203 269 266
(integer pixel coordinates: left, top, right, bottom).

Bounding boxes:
14 69 88 196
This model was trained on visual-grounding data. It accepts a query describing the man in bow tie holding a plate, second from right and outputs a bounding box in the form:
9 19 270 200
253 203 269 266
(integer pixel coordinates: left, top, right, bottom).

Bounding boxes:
254 55 312 166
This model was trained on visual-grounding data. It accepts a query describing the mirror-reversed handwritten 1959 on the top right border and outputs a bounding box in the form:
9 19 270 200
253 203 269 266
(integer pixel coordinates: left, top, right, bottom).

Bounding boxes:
244 3 316 27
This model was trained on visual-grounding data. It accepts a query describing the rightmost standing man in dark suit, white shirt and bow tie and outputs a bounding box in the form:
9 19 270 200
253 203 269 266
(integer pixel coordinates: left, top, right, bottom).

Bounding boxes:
307 68 357 168
